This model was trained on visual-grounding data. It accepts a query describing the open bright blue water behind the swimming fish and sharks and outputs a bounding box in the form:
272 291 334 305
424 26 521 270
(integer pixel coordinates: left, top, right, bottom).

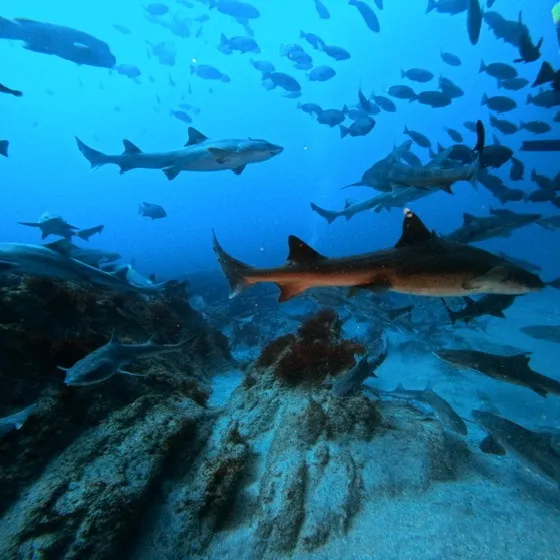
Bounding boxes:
0 0 560 277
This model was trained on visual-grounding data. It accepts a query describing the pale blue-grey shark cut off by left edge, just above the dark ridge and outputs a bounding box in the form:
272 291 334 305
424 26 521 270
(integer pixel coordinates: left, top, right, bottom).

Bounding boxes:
0 239 169 294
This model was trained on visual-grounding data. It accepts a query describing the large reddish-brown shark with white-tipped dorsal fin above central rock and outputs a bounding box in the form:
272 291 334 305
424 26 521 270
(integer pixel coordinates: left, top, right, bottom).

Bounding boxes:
213 209 544 302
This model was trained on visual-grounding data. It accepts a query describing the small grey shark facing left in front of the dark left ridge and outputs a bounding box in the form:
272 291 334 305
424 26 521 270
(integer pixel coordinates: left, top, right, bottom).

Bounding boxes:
58 334 192 387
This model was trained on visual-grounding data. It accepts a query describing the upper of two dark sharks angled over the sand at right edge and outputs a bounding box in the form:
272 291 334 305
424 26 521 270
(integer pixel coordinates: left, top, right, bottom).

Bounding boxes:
435 348 560 397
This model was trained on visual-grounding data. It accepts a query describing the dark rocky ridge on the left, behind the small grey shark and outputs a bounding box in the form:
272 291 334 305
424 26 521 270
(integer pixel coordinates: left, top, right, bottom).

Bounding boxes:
0 278 231 558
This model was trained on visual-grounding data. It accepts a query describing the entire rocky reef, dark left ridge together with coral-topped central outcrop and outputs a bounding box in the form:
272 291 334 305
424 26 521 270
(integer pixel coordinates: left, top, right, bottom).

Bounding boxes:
0 296 469 560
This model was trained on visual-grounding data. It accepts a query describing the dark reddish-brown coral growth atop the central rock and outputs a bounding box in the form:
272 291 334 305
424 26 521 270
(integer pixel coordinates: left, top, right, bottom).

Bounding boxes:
256 309 366 385
